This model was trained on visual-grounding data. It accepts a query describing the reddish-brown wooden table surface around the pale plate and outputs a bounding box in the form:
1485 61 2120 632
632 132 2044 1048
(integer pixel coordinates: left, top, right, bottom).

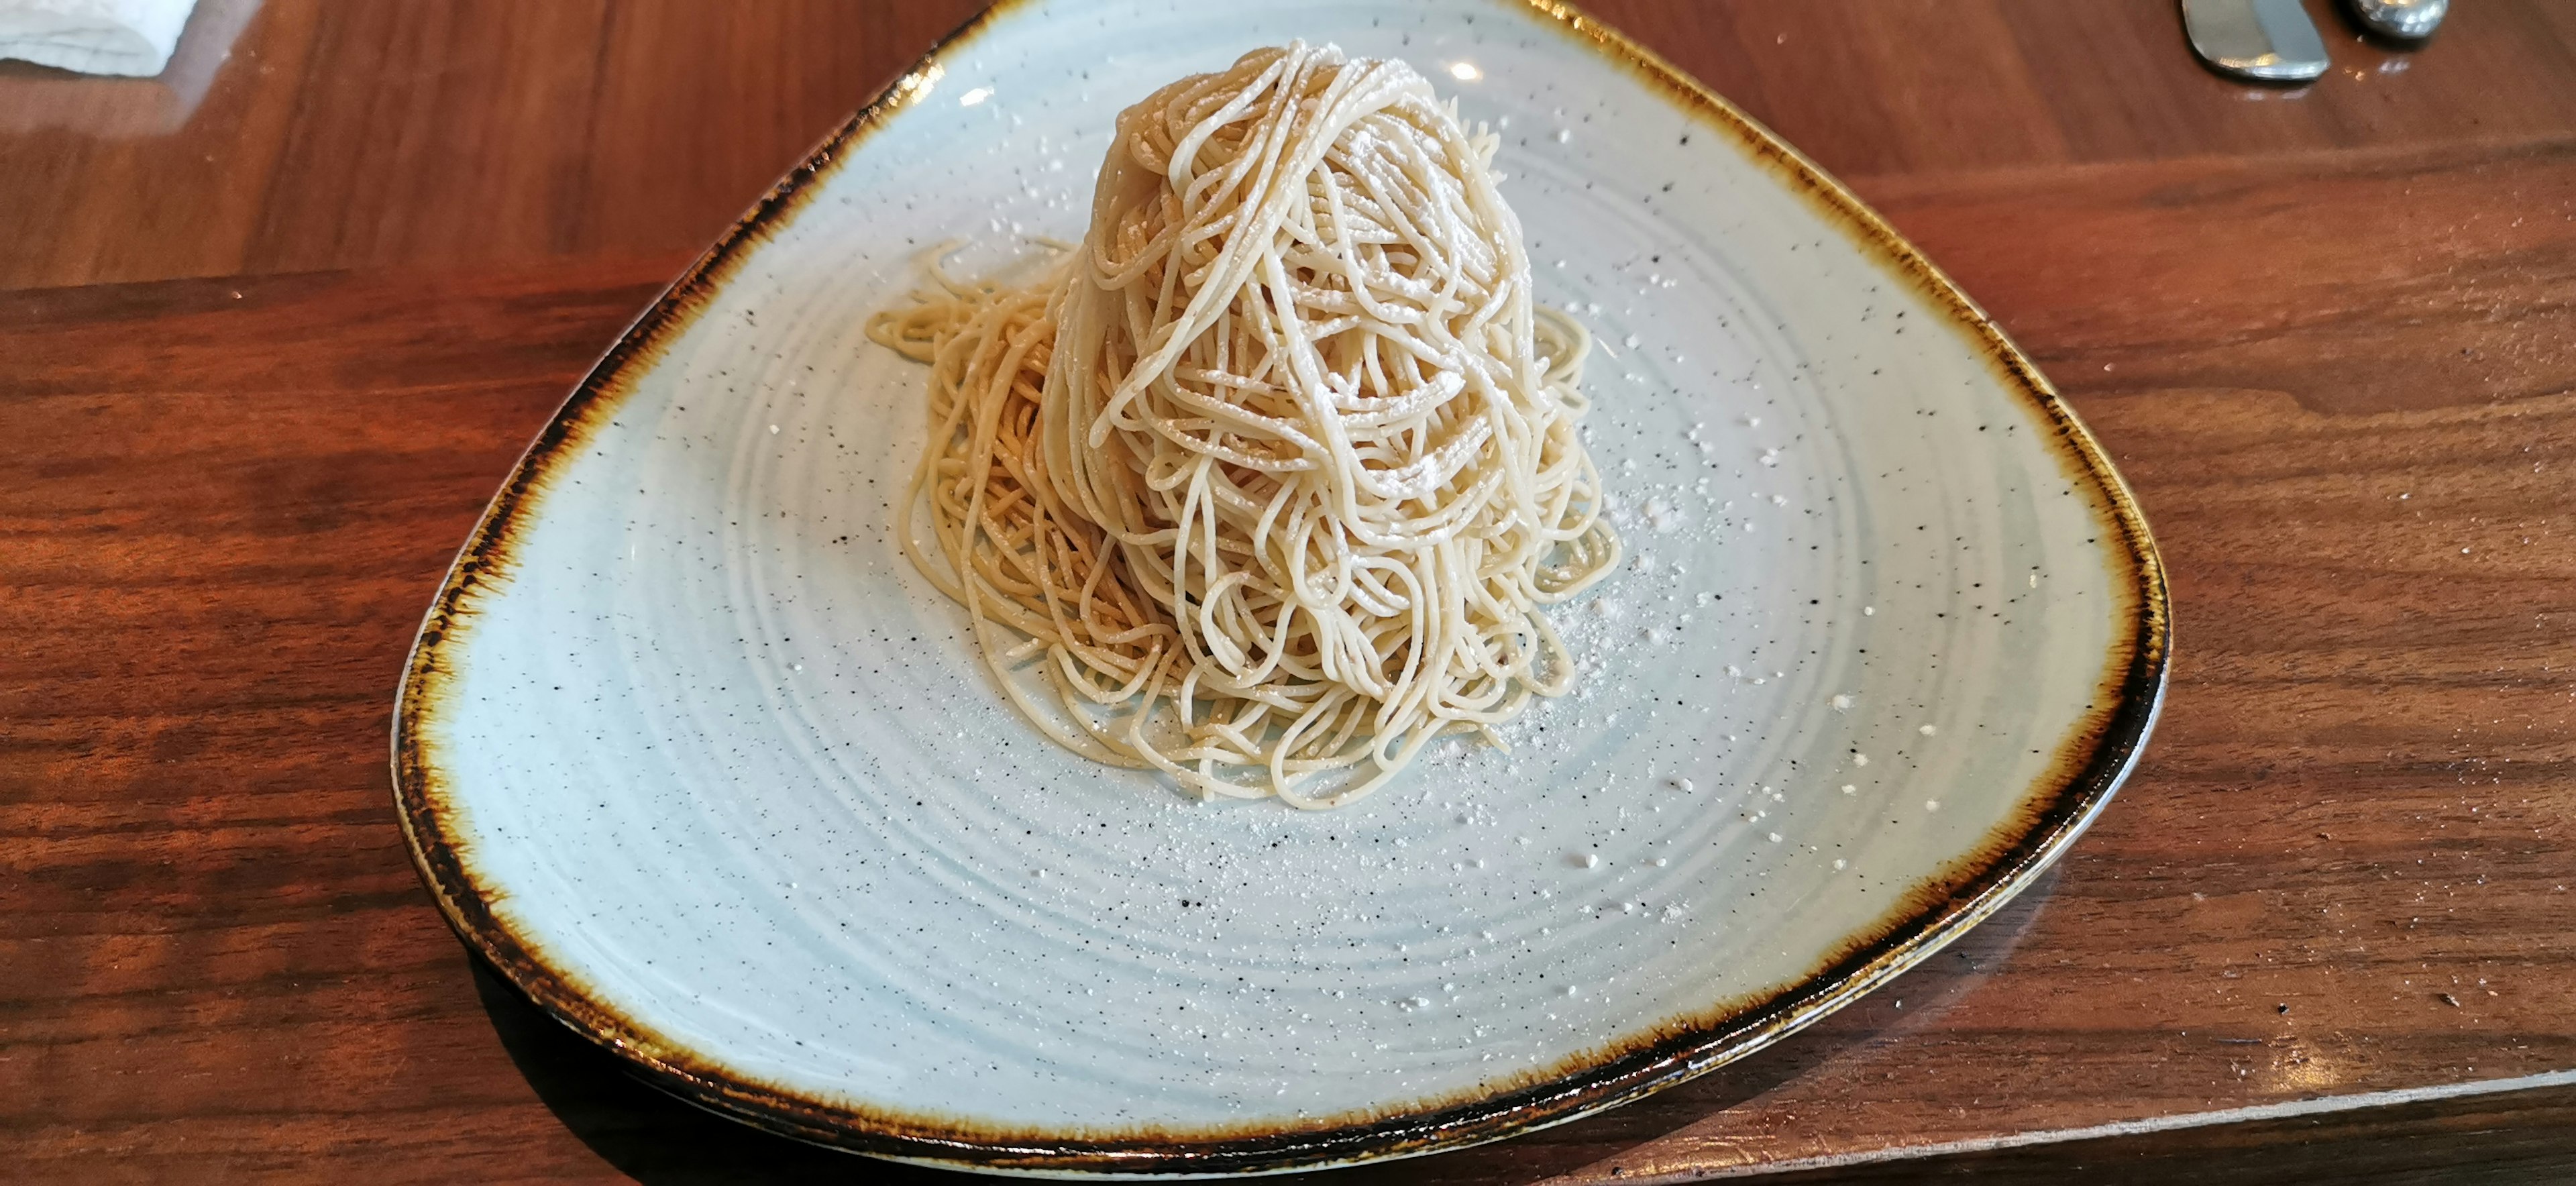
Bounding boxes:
0 0 2576 1183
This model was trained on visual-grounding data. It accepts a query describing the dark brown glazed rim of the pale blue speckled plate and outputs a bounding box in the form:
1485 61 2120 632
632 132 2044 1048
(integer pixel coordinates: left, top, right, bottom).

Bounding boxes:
394 0 2169 1176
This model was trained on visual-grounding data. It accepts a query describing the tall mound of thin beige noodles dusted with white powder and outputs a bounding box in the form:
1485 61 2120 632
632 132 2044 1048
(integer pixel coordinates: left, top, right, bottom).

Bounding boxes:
868 44 1620 807
